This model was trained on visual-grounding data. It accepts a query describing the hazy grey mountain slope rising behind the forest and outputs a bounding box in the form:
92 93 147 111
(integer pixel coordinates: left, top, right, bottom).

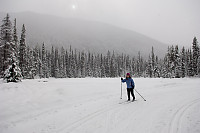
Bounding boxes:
0 12 167 56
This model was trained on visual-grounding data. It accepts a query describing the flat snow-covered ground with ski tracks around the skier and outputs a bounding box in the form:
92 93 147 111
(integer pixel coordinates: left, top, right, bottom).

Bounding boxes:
0 78 200 133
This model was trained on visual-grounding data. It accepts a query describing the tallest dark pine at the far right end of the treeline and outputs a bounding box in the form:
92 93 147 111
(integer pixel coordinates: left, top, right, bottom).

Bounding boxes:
192 37 199 75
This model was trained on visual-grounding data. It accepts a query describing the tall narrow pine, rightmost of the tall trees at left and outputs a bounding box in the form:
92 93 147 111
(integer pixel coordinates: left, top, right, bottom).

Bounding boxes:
19 24 27 78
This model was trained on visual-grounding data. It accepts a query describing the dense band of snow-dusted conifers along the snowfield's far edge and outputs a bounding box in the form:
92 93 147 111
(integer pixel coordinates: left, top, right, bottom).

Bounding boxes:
0 14 200 81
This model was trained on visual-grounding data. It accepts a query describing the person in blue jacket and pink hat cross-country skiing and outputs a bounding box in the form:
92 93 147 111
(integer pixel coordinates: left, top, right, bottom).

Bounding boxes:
121 73 135 101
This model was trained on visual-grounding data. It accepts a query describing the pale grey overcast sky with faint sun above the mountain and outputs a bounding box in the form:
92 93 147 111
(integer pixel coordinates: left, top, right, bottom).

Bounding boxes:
0 0 200 46
